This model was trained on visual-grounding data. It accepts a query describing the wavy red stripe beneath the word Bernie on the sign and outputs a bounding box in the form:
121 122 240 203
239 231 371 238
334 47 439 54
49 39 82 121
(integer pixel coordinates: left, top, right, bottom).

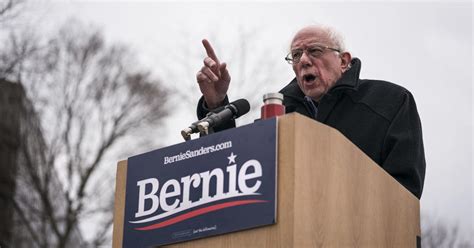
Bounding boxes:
135 200 267 231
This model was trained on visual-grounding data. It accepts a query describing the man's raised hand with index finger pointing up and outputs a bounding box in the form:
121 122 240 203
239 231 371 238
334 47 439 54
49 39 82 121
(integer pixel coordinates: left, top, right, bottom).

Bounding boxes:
196 39 230 109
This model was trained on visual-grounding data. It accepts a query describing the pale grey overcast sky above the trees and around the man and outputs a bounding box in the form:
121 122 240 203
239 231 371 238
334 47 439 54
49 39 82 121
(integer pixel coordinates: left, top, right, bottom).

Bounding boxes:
25 1 474 241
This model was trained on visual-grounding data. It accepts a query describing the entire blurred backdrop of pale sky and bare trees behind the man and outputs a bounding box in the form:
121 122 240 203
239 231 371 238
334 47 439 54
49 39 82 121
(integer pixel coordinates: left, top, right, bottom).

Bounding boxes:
0 0 474 247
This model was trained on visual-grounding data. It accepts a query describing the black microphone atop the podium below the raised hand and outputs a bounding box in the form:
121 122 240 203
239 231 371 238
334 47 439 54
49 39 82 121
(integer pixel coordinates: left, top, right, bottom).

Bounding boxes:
181 99 250 140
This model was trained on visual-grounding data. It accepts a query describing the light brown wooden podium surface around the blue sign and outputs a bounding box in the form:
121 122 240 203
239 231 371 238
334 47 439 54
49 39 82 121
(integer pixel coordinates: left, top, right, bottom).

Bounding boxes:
113 114 420 248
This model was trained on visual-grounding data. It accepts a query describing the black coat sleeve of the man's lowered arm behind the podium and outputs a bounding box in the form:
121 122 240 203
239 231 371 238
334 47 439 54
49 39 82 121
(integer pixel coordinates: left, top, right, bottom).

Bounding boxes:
382 91 426 198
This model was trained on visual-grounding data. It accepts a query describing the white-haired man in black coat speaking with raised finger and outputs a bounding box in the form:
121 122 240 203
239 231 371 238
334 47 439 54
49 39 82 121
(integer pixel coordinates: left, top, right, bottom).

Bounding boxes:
196 26 425 198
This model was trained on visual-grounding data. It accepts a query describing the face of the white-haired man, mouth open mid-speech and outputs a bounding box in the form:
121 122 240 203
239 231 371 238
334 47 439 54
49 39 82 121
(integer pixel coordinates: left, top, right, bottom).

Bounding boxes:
291 28 347 101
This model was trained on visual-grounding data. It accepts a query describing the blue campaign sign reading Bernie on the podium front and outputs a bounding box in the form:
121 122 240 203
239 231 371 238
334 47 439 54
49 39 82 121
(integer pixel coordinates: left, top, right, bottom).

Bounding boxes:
123 118 277 247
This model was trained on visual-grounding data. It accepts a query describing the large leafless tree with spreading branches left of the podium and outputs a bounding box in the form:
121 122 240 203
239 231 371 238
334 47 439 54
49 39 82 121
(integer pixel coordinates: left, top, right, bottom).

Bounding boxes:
3 21 167 247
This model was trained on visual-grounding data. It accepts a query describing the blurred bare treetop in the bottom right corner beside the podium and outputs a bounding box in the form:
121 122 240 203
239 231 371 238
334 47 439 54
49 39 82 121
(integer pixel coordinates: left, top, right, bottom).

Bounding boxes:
421 215 474 248
